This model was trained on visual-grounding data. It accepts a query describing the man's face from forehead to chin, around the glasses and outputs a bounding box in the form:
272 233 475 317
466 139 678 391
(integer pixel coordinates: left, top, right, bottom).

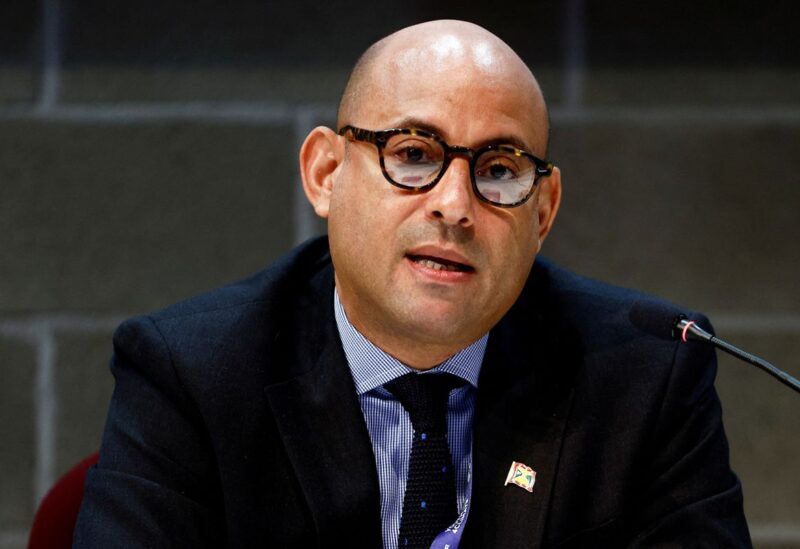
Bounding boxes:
318 34 557 367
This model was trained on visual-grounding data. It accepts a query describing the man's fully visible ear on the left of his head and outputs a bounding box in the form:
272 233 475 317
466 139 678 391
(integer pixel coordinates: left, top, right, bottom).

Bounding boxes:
300 126 344 218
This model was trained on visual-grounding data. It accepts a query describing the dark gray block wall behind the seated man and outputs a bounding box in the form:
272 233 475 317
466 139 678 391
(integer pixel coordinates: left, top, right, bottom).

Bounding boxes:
0 0 800 549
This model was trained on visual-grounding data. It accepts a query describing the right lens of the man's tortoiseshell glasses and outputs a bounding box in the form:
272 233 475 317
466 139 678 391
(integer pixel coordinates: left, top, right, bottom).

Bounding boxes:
475 147 536 205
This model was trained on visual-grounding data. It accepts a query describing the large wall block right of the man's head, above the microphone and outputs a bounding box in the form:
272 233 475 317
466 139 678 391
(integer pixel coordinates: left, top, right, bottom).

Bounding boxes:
543 122 800 313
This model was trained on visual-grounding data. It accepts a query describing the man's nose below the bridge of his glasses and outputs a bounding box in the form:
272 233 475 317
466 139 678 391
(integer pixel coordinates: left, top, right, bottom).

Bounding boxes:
427 156 477 227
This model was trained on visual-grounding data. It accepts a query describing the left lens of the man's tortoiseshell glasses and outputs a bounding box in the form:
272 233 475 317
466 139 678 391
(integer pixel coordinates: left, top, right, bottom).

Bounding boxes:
383 134 444 188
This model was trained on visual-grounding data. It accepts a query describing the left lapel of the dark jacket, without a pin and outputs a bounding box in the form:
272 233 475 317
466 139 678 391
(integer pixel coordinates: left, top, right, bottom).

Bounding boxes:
264 267 382 548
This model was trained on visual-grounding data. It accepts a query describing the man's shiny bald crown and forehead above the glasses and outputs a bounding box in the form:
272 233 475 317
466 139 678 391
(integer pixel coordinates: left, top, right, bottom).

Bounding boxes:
339 21 548 154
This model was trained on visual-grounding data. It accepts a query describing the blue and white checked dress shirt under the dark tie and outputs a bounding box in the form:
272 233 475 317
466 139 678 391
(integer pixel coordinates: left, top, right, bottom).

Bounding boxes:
333 290 489 549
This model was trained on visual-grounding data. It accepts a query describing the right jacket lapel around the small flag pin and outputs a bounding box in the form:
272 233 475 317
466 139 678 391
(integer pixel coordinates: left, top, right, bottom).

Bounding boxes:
461 270 582 547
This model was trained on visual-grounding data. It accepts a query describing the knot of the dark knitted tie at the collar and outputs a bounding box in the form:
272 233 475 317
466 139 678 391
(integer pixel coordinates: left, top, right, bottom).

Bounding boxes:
385 372 466 433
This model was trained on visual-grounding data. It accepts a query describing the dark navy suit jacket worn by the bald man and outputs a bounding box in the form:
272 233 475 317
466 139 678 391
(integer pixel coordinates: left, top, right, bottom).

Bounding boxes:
75 239 750 548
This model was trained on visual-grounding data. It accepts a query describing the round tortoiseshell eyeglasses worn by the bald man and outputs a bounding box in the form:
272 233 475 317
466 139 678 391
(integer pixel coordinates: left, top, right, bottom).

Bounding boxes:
339 126 553 208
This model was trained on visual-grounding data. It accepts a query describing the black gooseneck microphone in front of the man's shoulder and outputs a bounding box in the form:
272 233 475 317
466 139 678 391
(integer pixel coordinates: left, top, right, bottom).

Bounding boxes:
628 299 800 393
